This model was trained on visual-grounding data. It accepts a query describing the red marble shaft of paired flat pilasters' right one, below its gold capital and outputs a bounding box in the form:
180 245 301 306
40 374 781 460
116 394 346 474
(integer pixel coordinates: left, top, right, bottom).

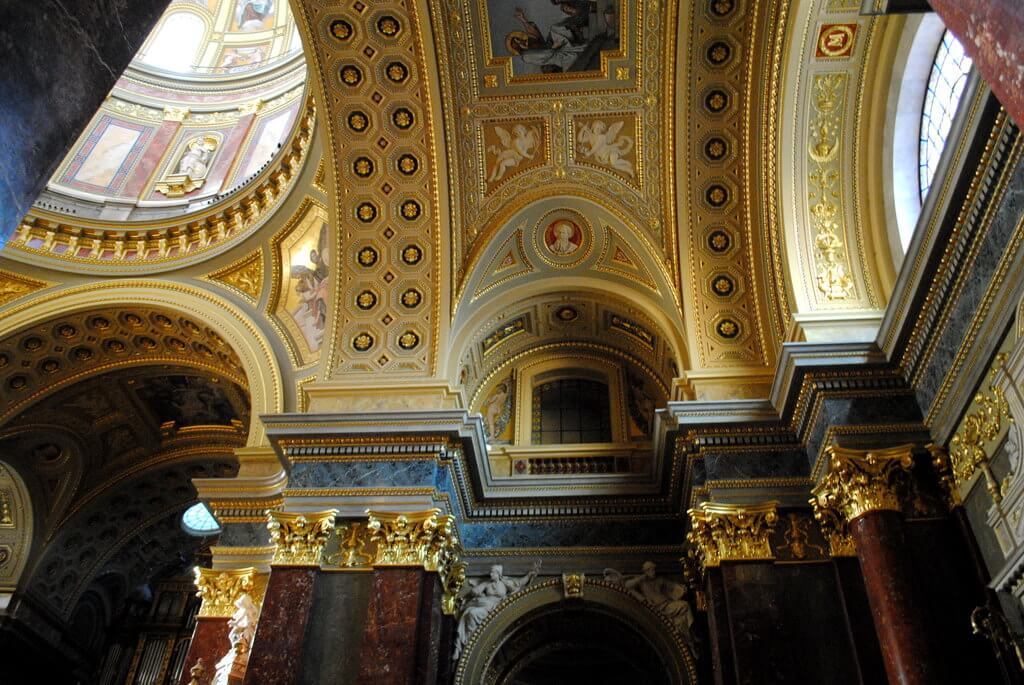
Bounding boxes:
356 567 446 685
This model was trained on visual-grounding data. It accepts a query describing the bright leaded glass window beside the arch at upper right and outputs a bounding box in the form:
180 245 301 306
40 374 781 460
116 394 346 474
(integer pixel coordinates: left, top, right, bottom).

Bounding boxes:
919 31 971 202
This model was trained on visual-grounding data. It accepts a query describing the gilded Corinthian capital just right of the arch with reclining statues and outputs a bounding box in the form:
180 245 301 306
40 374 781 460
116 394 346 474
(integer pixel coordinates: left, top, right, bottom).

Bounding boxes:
686 502 778 568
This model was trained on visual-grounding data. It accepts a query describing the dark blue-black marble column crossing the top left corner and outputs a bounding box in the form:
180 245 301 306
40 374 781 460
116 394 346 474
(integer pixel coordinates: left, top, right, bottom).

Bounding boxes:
0 0 168 247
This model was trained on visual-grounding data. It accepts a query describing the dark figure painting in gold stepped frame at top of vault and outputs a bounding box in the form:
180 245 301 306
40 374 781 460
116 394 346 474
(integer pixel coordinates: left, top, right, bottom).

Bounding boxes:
487 0 620 76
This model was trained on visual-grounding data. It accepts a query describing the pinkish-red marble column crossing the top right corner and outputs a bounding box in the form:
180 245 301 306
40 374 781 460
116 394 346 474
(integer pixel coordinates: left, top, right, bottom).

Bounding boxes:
929 0 1024 124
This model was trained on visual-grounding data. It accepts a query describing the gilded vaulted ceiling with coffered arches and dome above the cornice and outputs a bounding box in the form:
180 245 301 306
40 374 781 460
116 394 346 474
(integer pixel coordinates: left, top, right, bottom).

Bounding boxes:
0 0 937 651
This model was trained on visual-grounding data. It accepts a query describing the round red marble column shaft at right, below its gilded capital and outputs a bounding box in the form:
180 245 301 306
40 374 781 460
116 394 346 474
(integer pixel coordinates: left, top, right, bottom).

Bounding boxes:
850 509 946 685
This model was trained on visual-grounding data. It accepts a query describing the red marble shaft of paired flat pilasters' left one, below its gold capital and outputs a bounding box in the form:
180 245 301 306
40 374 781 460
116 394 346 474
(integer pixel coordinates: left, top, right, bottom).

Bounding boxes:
245 566 318 685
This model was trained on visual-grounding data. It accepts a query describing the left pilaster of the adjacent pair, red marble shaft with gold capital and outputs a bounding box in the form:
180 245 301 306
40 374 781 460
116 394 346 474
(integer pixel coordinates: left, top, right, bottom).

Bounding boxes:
244 510 336 685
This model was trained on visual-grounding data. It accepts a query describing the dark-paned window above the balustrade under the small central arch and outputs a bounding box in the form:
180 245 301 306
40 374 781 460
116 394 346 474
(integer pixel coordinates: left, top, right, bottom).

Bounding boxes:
532 378 611 444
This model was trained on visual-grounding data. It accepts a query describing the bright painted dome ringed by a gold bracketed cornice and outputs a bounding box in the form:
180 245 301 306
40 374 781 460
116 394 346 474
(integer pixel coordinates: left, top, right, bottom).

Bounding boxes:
12 0 312 266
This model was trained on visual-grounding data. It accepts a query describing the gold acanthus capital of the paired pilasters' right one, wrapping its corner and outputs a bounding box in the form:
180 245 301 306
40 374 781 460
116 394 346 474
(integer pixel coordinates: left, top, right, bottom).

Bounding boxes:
367 509 466 615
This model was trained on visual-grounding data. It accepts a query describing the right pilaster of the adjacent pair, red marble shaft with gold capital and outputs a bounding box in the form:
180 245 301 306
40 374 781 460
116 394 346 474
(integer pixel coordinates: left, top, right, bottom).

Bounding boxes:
356 509 465 685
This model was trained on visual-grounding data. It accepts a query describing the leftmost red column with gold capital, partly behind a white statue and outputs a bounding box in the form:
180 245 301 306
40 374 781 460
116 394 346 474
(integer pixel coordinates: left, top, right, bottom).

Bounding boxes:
178 567 266 685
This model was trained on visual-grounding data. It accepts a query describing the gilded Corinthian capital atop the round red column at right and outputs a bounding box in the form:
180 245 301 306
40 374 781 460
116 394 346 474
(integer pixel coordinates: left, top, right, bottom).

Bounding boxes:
811 444 913 534
